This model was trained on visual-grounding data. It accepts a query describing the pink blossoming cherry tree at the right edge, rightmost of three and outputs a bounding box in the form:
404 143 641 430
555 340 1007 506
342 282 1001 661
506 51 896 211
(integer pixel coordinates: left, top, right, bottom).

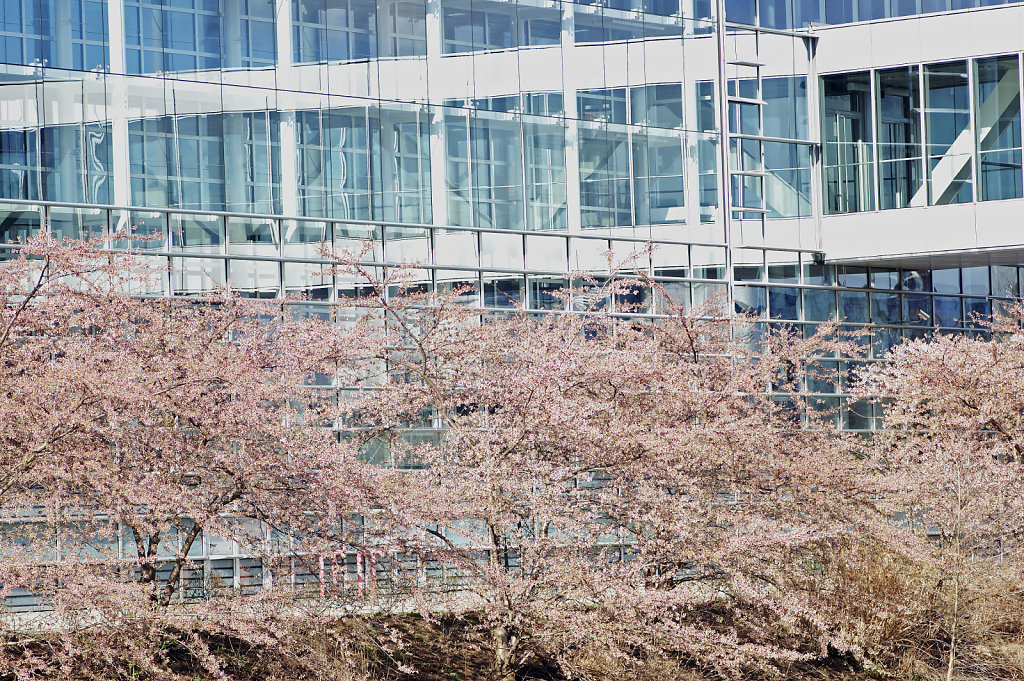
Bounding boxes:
858 304 1024 679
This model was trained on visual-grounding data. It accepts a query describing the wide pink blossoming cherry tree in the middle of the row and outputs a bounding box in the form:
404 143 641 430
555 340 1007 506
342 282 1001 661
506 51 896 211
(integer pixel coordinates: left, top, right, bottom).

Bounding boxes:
343 259 877 681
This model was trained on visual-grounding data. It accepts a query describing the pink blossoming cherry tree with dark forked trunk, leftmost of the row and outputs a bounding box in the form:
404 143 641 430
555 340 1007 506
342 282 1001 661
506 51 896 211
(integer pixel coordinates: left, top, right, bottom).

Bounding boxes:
0 235 399 675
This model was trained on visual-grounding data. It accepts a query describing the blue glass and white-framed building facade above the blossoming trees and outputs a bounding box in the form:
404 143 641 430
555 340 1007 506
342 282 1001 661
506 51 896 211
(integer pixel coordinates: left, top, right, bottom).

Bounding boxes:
9 0 1024 607
